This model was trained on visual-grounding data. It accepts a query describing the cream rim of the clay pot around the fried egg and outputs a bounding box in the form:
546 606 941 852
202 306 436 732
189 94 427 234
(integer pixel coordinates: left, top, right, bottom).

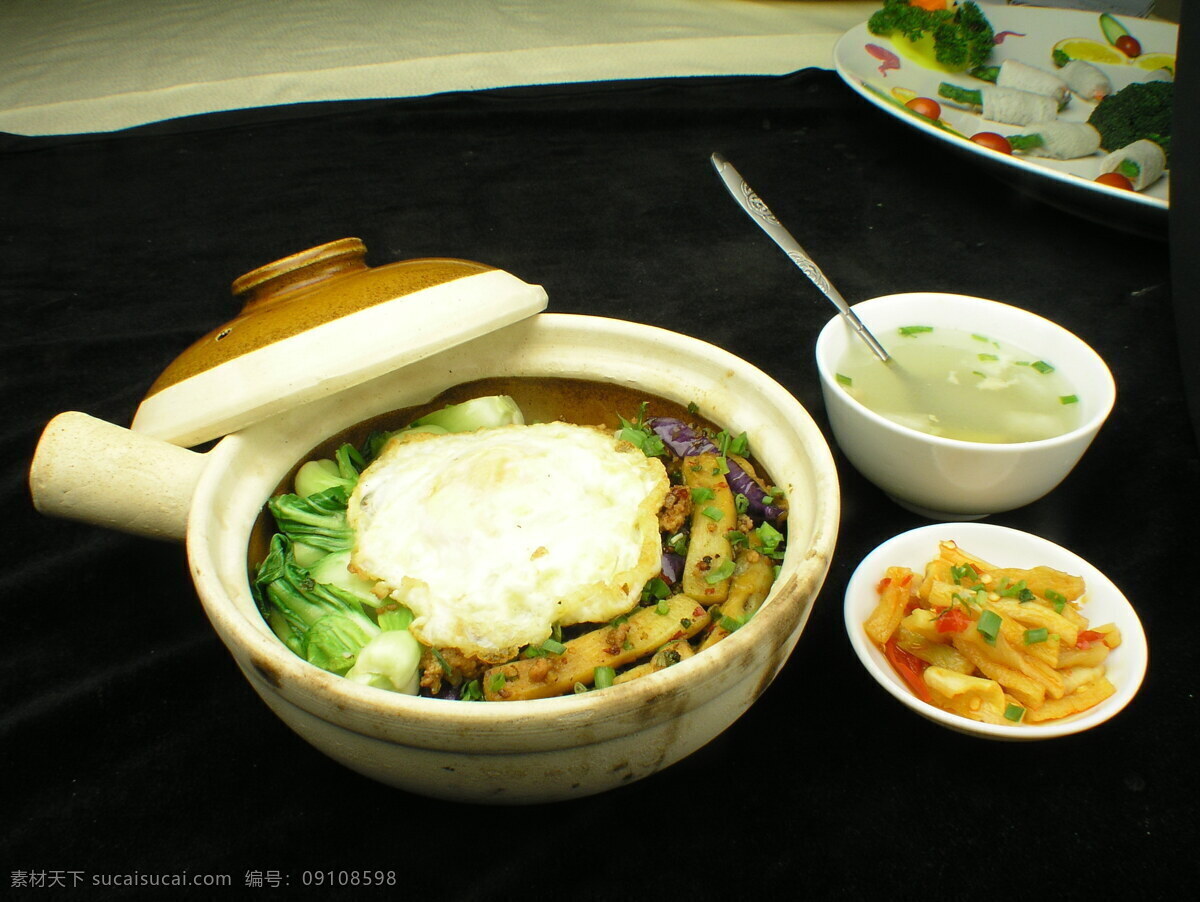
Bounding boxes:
187 313 840 751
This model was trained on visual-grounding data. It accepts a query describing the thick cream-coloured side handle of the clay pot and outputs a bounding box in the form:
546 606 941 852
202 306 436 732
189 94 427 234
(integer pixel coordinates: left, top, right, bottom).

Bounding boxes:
29 411 206 541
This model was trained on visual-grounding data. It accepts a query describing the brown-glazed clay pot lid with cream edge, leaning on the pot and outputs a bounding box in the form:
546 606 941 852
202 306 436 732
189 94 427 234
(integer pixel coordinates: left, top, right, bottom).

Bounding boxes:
132 237 547 447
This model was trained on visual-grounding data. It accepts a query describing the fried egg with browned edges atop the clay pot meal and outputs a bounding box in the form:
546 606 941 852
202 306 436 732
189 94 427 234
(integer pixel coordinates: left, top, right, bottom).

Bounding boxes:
348 422 668 662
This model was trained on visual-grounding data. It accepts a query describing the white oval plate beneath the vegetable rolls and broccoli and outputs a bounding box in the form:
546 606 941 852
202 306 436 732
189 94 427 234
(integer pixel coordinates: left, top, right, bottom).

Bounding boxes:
834 5 1178 218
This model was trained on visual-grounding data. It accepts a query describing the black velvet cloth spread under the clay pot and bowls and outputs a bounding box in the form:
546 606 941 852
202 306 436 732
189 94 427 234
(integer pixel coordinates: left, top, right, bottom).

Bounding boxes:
0 65 1200 900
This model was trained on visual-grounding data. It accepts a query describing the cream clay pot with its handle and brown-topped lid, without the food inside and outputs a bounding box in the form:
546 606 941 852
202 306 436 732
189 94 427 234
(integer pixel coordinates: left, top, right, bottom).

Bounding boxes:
30 239 839 802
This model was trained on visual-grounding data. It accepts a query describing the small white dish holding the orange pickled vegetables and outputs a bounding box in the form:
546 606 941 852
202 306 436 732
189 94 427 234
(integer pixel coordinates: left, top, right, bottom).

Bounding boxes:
845 523 1148 741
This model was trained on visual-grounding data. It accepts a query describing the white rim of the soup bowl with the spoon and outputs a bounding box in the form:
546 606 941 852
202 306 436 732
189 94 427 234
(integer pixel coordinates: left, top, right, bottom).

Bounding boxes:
816 291 1117 455
